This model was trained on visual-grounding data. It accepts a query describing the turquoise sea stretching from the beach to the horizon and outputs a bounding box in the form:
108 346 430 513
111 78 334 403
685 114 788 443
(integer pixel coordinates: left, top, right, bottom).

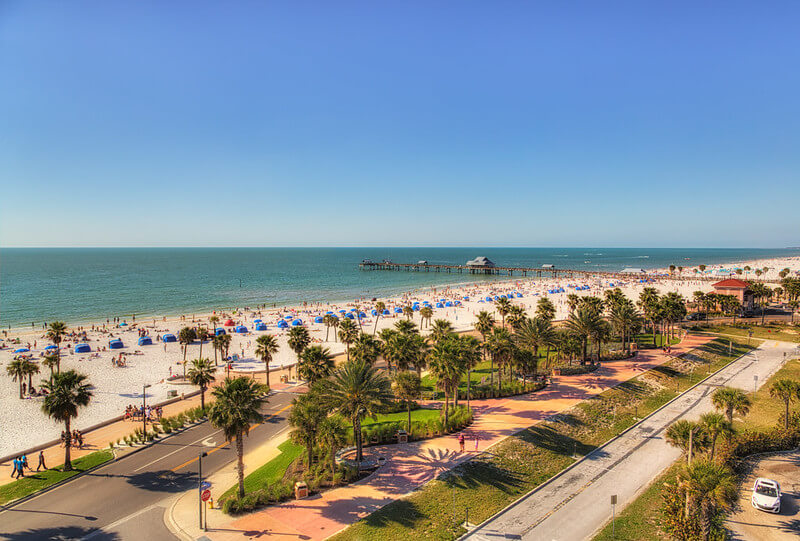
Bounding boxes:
0 248 800 327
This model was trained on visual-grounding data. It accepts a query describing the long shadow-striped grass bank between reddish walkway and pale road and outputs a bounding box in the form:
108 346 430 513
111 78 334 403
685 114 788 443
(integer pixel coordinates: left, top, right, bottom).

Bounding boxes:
333 340 752 541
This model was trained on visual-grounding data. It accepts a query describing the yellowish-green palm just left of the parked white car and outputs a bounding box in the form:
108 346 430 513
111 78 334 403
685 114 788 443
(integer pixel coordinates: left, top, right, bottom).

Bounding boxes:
678 460 738 540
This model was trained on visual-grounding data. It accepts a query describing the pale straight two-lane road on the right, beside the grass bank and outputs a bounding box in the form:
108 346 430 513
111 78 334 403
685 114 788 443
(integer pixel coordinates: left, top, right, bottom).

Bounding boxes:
465 341 796 541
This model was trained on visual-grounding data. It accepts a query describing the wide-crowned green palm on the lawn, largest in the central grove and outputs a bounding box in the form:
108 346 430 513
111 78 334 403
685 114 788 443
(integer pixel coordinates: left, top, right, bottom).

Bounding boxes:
320 360 392 463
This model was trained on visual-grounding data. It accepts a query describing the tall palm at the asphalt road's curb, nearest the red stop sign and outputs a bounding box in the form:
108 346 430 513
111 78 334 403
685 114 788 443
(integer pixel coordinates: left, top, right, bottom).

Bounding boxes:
208 376 269 498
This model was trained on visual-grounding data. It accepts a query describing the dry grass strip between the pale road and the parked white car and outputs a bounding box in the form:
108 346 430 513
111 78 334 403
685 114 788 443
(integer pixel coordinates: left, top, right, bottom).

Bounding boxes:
594 350 800 541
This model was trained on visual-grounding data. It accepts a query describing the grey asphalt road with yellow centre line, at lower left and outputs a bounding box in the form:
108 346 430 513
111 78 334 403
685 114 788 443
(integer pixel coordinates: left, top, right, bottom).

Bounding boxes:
0 392 295 541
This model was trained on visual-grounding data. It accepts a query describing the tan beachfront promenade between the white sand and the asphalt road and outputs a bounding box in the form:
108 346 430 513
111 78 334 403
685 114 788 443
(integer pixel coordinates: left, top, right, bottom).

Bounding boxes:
0 362 291 486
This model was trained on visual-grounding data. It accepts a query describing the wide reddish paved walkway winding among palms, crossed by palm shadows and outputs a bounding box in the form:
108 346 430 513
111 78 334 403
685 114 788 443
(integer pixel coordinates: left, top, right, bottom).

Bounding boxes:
174 336 712 541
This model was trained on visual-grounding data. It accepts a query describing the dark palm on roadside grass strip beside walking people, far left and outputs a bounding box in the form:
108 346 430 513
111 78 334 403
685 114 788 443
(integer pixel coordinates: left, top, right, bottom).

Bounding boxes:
42 370 92 471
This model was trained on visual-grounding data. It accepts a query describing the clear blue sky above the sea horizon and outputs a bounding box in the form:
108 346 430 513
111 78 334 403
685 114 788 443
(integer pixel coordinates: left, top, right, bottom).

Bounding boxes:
0 0 800 247
